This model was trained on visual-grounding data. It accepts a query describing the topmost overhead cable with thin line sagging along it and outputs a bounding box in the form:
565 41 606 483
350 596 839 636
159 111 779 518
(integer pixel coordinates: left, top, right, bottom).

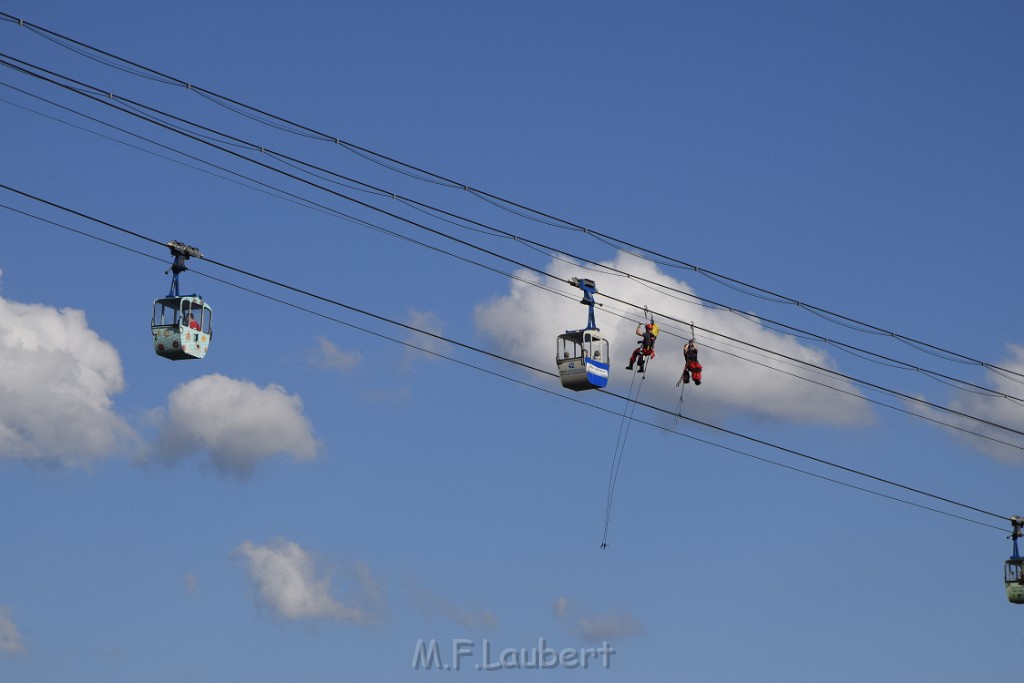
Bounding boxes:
0 11 1024 382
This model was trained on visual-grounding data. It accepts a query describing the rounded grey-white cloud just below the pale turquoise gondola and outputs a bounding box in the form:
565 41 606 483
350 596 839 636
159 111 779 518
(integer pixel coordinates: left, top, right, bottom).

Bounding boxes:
158 375 317 477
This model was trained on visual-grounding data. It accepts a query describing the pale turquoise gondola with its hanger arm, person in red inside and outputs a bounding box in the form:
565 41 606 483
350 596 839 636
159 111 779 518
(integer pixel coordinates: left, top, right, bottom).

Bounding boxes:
151 242 213 360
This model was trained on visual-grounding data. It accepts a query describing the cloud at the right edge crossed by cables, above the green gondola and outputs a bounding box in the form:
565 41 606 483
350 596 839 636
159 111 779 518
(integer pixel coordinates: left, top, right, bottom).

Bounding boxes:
937 344 1024 465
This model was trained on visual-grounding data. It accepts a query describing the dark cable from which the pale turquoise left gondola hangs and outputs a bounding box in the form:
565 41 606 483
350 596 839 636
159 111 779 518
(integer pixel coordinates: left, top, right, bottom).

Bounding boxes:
0 184 1013 530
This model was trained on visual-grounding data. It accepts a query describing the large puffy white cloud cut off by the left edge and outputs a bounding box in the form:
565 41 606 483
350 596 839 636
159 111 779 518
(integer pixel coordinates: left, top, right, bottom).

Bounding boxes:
0 286 138 465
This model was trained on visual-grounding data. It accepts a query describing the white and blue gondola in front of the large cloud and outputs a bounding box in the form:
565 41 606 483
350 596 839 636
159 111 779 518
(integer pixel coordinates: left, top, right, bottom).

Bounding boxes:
555 278 610 391
